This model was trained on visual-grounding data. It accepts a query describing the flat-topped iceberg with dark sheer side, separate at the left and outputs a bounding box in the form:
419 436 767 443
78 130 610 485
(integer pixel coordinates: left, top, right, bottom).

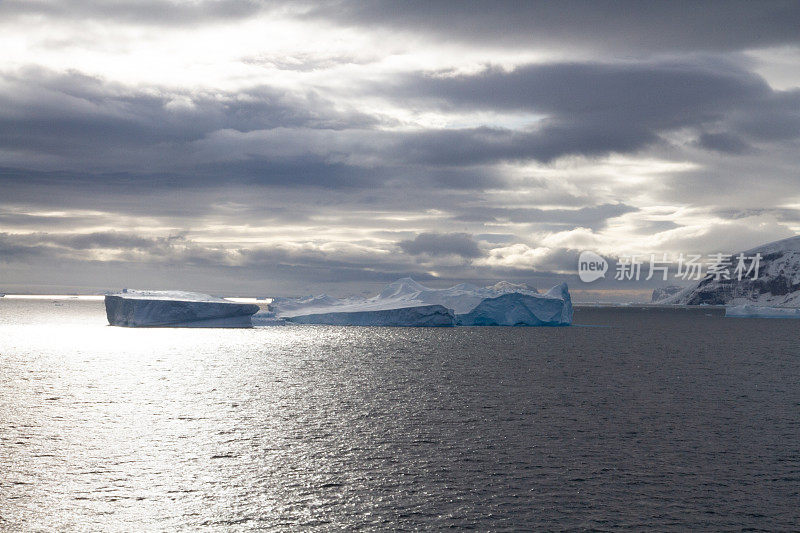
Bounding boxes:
105 290 259 328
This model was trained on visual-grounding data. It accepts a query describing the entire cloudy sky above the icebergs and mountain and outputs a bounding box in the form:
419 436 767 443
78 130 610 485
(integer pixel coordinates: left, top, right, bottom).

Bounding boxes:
0 0 800 295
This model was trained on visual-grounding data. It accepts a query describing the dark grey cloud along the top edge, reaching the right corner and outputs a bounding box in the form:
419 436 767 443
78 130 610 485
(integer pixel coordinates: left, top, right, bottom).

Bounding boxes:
309 0 800 54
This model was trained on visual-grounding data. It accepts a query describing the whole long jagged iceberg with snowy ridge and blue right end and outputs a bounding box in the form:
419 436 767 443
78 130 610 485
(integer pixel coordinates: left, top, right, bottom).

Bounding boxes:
270 278 572 326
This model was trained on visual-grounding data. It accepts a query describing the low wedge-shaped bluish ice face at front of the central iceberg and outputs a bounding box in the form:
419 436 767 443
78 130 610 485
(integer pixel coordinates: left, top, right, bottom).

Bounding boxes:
286 305 455 327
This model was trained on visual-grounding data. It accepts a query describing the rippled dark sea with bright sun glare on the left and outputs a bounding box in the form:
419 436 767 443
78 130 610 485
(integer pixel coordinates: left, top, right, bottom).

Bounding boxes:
0 299 800 531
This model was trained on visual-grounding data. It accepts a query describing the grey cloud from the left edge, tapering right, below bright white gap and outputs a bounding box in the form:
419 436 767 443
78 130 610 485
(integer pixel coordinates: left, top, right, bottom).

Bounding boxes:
0 69 375 158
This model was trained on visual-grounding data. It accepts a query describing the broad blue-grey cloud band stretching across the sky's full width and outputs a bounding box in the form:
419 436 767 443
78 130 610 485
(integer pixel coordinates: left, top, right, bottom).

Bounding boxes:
0 60 800 204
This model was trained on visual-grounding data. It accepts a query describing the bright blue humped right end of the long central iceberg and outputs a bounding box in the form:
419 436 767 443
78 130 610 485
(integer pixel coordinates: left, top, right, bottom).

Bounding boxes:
456 283 572 326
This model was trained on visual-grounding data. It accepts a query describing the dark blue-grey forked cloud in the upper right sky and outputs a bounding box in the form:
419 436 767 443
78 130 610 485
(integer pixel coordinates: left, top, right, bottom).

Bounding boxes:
393 58 800 164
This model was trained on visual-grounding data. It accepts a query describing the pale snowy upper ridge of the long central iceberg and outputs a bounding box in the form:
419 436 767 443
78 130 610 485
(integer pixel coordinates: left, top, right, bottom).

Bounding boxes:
270 278 538 317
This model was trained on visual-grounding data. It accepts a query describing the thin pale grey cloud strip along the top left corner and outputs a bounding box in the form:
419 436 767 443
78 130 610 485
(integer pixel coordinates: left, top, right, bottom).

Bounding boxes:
0 0 268 26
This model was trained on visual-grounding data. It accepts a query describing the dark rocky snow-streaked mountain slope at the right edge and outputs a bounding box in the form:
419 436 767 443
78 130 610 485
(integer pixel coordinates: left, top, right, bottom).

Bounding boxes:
658 236 800 307
